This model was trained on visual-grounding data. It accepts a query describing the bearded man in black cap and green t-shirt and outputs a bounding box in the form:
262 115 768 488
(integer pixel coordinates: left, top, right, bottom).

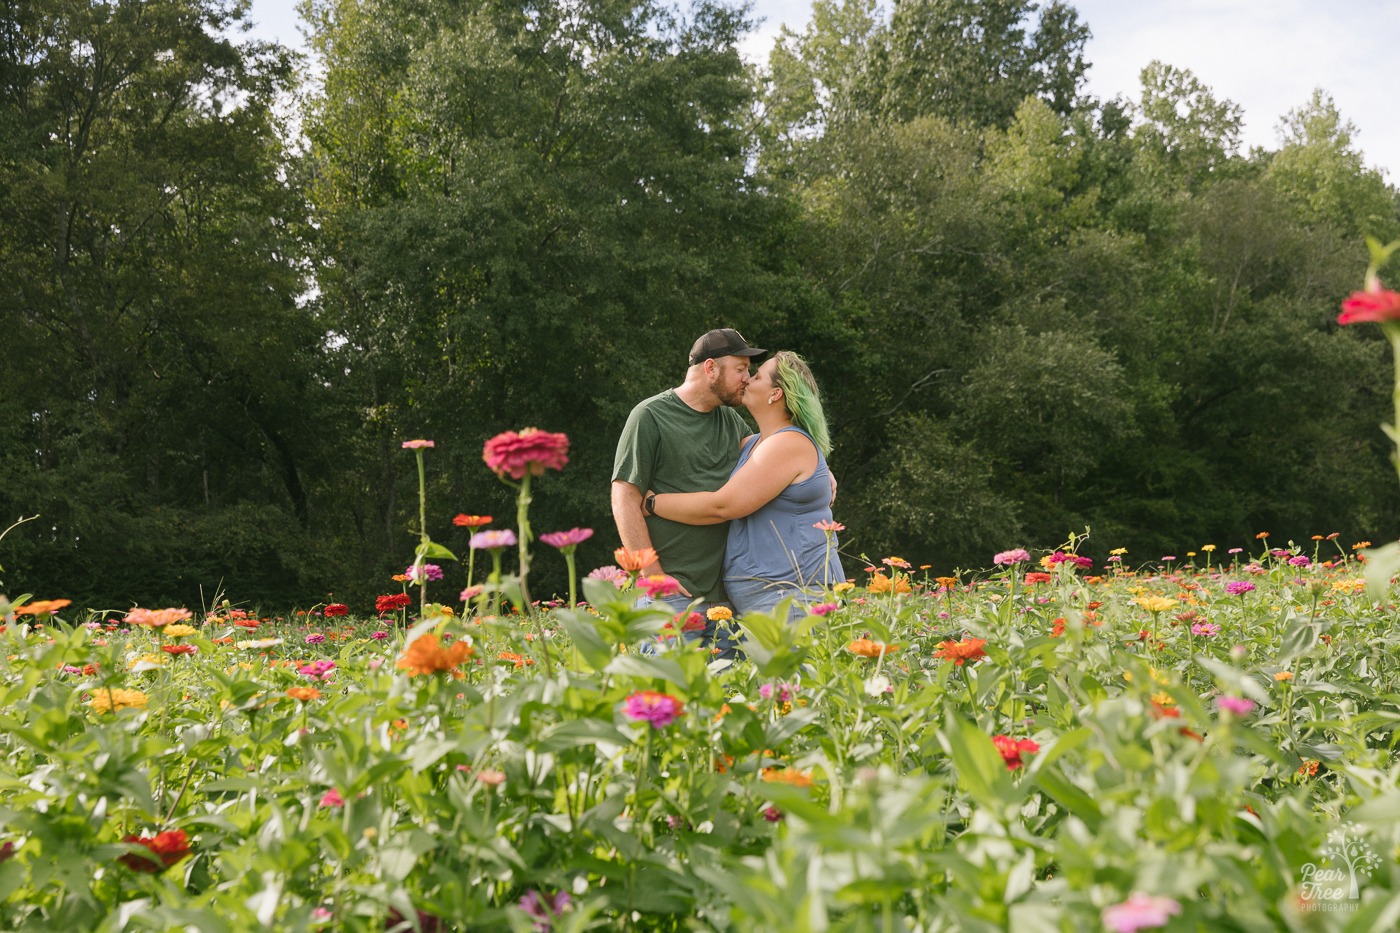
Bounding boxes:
612 328 766 643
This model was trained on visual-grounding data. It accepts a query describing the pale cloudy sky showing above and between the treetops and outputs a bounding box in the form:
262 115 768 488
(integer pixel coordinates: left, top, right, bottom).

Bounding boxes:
252 0 1400 185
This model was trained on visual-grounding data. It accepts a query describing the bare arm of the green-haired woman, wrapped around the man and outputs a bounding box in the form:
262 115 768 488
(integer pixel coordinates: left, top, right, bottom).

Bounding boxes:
654 431 816 525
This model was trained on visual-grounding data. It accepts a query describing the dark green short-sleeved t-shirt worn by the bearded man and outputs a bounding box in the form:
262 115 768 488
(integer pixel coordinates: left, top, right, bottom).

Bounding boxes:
613 389 752 602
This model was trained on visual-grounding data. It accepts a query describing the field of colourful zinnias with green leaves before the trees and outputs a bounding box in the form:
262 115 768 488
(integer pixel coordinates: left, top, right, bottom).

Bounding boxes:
0 539 1400 930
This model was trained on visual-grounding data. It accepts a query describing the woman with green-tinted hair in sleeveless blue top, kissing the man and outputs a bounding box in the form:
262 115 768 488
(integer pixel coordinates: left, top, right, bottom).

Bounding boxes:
644 350 846 614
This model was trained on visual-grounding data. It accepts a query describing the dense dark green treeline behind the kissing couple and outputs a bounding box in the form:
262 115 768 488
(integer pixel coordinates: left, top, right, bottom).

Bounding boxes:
0 0 1400 611
